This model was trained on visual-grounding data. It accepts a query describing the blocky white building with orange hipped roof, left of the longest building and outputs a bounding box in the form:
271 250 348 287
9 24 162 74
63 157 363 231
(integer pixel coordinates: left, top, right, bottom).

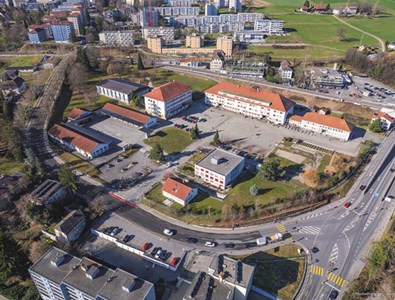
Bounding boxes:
144 81 192 119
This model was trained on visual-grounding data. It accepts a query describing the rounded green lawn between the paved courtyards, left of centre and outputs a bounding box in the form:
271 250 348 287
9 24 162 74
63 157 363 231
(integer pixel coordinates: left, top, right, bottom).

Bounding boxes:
144 127 192 154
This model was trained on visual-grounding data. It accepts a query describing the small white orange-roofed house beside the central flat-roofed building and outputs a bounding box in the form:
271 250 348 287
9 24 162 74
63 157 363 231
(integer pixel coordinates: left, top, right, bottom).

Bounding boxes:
162 177 198 206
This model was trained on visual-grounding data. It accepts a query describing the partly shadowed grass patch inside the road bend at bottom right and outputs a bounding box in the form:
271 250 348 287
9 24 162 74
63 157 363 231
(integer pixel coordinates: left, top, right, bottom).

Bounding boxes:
236 245 305 300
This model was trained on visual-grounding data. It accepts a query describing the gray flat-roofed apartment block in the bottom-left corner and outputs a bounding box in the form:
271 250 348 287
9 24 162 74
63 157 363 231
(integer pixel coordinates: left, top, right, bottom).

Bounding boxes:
29 247 156 300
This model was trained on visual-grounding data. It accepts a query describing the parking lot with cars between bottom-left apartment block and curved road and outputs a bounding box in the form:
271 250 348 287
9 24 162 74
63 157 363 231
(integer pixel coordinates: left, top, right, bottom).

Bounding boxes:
94 213 190 267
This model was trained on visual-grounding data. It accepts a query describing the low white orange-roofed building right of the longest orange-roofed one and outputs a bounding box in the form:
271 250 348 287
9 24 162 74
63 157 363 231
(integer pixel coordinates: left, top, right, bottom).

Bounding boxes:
288 112 354 141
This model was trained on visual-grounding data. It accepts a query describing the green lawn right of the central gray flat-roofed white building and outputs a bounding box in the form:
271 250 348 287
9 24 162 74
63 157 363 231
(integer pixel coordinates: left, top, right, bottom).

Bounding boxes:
225 173 307 208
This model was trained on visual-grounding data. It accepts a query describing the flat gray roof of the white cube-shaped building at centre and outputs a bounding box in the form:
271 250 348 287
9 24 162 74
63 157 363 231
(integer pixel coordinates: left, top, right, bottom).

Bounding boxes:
196 148 244 176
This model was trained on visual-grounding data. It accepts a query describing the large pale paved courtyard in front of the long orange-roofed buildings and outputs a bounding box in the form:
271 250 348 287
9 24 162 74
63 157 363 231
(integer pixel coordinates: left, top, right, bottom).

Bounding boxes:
172 102 378 155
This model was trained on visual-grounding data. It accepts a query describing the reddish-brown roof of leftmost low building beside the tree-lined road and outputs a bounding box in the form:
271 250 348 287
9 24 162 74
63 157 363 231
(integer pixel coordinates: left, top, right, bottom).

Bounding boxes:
48 124 99 153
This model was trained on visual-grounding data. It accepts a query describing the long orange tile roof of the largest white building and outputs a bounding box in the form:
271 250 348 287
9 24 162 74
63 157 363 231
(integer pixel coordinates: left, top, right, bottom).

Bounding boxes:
205 81 294 112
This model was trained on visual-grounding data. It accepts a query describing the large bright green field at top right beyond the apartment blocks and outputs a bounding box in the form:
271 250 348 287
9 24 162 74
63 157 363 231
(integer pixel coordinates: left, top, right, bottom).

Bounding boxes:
249 0 395 60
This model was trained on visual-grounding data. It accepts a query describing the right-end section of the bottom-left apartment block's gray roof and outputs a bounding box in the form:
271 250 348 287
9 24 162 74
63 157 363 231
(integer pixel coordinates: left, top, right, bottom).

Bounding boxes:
98 269 153 300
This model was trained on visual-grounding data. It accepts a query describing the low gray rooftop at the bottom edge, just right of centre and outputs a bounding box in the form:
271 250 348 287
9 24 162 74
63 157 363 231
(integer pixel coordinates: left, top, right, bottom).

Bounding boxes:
183 271 234 300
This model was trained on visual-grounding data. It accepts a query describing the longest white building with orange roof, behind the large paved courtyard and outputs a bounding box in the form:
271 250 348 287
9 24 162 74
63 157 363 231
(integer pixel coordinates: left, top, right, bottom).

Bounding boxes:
205 81 295 124
